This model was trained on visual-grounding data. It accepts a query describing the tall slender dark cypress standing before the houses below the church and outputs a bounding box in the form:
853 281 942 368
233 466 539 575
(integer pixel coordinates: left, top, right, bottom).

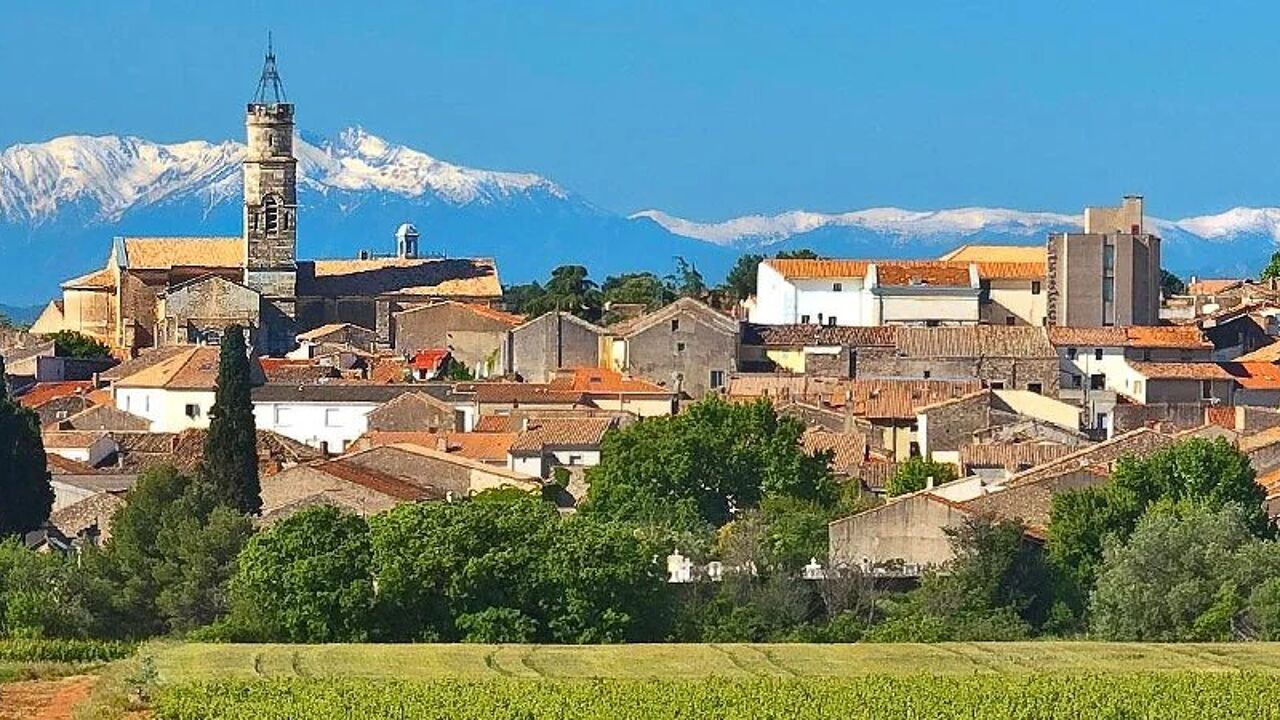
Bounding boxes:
201 325 262 515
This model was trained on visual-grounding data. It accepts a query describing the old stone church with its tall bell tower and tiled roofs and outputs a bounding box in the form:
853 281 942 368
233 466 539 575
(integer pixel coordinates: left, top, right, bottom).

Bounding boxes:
32 49 502 355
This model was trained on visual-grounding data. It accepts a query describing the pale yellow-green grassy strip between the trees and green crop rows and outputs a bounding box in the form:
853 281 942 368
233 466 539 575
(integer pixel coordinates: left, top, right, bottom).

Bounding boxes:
149 642 1280 684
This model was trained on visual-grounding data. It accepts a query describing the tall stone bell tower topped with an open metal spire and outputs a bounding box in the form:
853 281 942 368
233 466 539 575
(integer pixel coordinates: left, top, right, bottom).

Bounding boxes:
243 40 298 352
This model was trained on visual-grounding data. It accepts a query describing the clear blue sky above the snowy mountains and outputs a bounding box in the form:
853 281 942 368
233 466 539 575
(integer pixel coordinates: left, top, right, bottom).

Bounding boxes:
0 0 1280 219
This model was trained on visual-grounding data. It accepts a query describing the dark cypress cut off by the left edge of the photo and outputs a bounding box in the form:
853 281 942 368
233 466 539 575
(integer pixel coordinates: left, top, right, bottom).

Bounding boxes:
0 357 54 537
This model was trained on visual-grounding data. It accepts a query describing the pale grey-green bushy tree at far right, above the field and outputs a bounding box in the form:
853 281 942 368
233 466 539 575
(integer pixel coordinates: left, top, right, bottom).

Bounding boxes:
1089 501 1280 642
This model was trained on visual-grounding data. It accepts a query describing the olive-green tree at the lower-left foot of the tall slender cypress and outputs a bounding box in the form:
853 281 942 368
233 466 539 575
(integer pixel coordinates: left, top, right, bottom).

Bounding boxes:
84 466 253 637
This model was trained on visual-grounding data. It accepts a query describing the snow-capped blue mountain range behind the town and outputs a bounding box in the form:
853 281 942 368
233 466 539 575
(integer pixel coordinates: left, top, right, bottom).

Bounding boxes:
0 127 1280 304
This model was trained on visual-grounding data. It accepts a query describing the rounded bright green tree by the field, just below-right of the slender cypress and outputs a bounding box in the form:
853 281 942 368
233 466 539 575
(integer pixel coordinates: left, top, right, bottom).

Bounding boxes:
228 506 374 643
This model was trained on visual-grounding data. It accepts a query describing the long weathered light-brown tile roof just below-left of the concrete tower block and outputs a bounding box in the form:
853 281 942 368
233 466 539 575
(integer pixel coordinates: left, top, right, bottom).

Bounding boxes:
897 325 1057 359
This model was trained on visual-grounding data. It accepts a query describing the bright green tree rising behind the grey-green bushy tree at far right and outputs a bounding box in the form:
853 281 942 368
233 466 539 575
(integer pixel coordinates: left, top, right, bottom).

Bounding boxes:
1048 438 1270 602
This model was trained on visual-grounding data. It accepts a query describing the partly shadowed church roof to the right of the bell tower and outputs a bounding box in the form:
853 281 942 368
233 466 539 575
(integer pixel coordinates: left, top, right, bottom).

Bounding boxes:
297 258 502 299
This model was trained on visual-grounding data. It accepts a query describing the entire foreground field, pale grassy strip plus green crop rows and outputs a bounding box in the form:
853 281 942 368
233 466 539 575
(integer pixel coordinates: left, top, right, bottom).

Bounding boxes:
104 642 1280 720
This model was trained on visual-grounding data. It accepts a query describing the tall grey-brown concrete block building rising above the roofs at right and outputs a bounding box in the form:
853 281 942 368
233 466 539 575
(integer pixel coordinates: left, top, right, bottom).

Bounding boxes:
1047 195 1160 328
